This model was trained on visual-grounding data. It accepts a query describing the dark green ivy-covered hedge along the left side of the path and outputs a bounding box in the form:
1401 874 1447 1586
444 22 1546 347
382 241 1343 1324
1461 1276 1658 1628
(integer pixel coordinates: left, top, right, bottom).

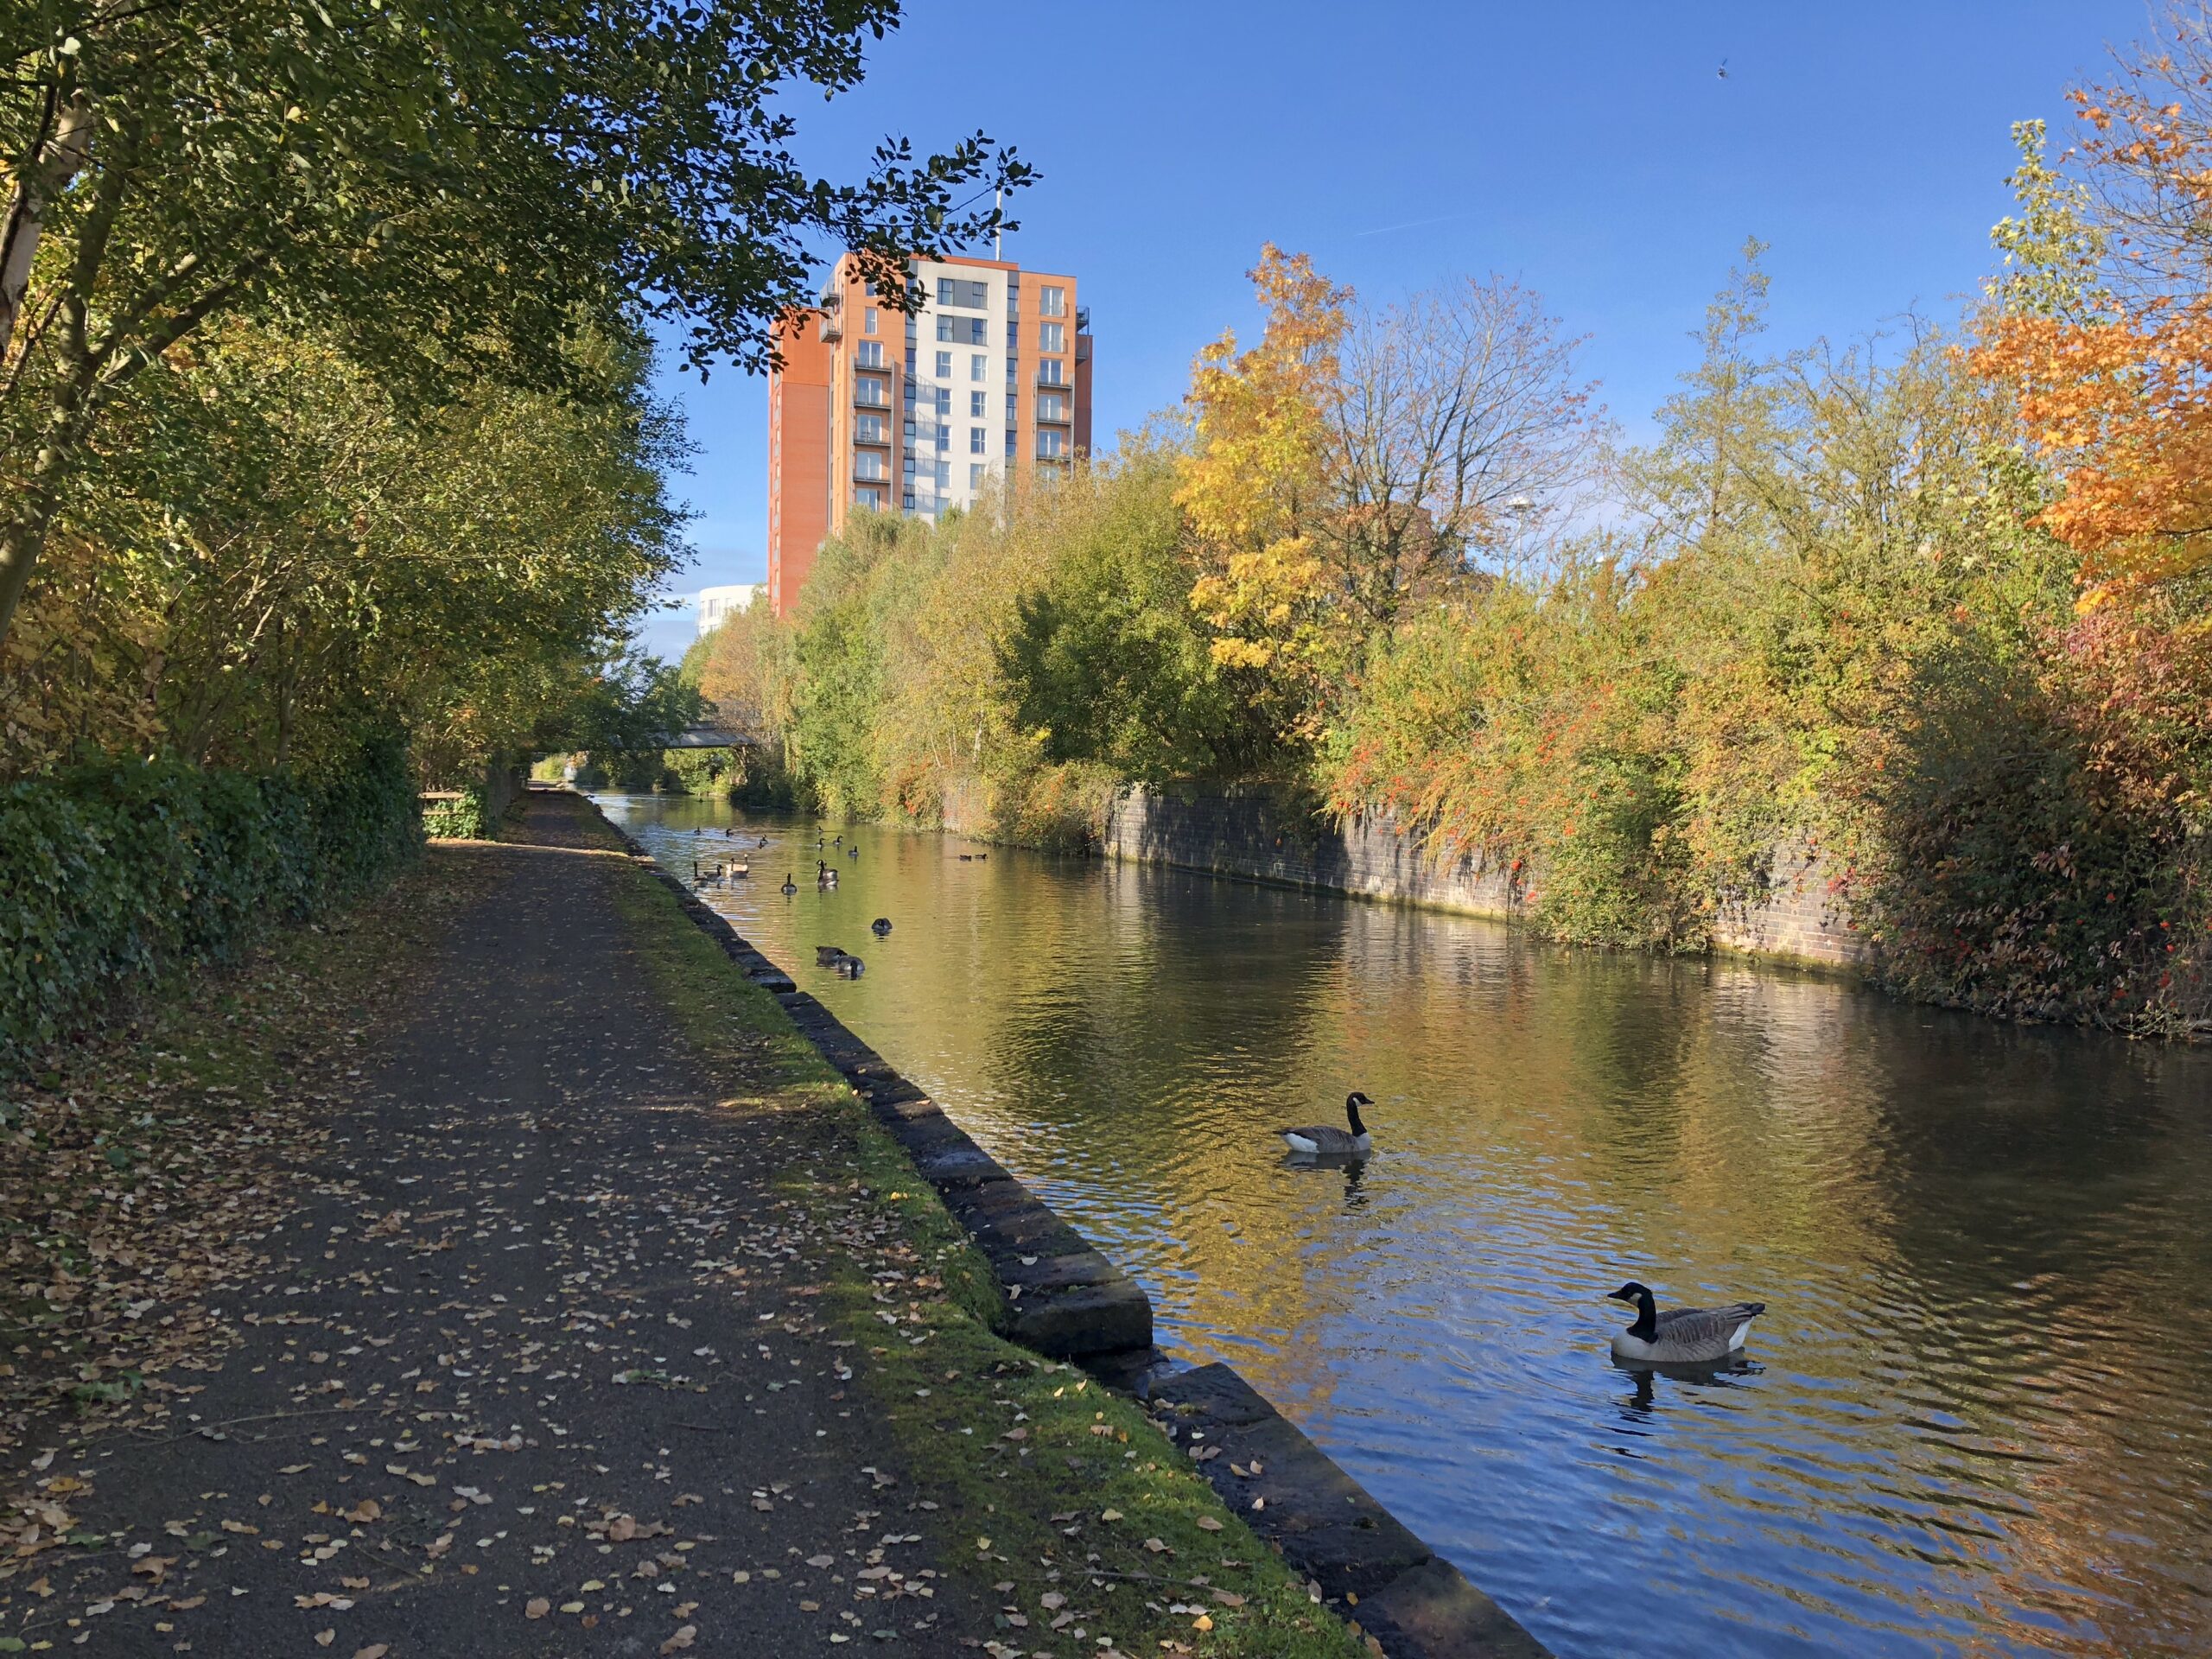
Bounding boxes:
0 741 423 1073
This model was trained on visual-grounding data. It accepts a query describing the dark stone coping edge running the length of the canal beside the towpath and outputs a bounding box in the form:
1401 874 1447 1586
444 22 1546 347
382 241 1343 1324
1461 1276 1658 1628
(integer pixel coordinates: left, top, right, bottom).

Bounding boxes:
575 790 1551 1659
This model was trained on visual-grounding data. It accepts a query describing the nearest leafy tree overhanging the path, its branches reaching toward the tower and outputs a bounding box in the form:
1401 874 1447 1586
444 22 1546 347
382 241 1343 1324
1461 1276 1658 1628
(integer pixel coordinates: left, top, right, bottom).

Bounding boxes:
0 0 1027 639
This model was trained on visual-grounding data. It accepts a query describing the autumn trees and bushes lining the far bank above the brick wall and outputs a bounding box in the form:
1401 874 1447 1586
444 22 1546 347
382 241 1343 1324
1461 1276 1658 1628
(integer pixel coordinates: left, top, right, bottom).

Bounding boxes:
695 40 2212 1033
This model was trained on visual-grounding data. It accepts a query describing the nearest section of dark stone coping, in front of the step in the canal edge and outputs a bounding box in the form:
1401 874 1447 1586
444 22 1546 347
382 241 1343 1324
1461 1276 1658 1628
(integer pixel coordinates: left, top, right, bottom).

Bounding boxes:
1150 1365 1546 1659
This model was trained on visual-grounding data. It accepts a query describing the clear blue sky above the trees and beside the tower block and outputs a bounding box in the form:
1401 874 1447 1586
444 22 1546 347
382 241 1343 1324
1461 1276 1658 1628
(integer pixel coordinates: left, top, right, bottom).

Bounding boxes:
646 0 2152 652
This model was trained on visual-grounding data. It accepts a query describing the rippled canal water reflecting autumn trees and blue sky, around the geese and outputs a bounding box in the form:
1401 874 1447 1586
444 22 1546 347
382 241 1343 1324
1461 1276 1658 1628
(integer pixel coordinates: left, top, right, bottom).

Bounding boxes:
604 797 2212 1659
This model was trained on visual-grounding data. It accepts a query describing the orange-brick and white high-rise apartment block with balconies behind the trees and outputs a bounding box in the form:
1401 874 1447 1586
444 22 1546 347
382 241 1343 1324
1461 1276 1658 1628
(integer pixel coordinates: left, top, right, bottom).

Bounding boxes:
767 254 1090 617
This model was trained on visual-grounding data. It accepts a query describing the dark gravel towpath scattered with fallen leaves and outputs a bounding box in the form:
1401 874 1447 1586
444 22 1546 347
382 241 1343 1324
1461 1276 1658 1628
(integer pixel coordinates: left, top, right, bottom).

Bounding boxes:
0 797 993 1659
